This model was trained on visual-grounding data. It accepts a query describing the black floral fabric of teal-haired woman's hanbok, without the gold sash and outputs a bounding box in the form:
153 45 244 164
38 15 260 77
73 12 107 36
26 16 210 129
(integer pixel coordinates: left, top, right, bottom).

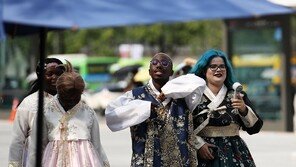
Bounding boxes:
193 90 263 167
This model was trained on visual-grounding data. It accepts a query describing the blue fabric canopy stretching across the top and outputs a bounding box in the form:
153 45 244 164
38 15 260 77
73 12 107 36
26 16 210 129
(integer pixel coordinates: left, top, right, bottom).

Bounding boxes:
2 0 294 34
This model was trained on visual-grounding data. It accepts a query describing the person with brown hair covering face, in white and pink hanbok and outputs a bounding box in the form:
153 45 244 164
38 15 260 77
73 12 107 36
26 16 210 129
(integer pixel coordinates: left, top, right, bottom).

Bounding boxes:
29 62 110 167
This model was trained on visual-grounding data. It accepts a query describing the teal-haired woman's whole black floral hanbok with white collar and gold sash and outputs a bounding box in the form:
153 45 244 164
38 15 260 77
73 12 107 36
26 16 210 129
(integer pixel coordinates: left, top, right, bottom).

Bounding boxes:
193 86 263 167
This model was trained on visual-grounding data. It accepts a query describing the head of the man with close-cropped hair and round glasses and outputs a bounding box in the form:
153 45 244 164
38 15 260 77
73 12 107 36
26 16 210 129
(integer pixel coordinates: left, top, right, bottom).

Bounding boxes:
149 53 173 85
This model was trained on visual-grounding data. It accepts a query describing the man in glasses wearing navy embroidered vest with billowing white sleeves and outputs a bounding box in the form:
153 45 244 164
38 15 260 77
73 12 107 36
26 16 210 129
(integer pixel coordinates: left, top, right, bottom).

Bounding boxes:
105 53 205 167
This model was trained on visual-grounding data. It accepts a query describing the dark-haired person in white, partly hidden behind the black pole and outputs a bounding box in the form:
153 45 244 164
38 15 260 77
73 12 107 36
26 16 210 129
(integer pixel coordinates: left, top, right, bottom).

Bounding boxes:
8 58 63 167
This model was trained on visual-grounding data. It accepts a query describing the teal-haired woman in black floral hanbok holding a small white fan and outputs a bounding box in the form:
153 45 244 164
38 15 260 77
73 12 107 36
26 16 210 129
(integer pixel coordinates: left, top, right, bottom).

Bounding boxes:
191 49 263 167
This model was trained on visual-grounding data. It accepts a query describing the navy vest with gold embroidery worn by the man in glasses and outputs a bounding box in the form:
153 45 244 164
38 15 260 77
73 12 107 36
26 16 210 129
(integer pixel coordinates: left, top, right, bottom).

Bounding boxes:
131 86 196 167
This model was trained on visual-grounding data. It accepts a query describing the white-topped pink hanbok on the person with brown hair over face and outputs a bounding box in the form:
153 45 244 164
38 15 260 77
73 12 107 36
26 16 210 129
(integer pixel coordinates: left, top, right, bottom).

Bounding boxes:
29 97 110 167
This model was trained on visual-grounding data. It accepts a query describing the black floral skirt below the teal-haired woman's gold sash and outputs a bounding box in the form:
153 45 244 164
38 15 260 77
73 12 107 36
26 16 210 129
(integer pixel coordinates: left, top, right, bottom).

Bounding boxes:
198 136 256 167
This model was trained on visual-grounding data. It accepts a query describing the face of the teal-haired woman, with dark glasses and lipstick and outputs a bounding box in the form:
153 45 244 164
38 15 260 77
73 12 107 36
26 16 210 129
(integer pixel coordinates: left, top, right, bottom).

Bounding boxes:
206 57 227 87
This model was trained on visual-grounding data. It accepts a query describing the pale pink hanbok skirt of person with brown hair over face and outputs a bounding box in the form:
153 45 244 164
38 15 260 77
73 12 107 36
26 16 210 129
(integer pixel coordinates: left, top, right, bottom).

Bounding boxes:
42 140 103 167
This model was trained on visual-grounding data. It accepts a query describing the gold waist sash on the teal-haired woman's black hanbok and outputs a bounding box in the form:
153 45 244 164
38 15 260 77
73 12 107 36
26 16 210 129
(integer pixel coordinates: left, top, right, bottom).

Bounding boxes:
198 123 240 137
